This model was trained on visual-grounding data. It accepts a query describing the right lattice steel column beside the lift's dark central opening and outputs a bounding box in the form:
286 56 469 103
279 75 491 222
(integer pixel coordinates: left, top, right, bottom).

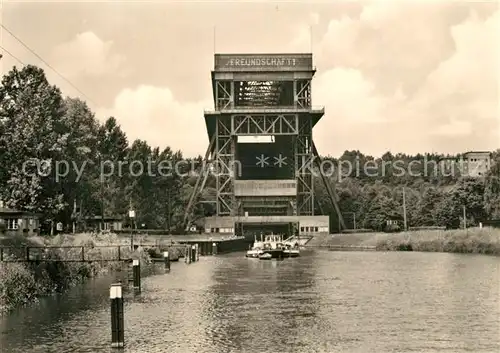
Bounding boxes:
294 116 314 216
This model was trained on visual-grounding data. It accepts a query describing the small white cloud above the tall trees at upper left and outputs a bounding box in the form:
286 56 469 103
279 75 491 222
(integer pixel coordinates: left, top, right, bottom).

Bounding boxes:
52 32 126 77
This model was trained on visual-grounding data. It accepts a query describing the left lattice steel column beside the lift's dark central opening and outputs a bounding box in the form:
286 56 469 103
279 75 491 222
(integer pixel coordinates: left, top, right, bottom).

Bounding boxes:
214 116 238 216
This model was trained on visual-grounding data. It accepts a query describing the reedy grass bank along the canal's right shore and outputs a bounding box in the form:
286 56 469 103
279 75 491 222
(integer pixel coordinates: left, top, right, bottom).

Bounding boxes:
321 228 500 256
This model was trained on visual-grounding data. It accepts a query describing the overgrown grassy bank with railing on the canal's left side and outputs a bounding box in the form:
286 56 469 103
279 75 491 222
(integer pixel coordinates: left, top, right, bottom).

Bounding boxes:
0 234 147 313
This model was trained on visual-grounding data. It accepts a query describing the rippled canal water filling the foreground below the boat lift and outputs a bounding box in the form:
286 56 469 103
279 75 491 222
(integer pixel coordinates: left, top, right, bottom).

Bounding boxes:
0 251 500 353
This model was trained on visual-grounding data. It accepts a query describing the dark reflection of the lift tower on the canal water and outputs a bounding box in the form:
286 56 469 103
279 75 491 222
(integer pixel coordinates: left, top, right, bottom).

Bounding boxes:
204 253 317 352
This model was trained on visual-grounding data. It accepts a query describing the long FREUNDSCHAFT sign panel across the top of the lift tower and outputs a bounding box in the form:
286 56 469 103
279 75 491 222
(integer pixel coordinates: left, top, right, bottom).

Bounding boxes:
215 54 312 71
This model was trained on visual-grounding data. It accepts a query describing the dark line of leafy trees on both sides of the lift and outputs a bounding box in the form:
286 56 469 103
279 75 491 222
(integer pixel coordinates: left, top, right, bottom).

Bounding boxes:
0 65 500 232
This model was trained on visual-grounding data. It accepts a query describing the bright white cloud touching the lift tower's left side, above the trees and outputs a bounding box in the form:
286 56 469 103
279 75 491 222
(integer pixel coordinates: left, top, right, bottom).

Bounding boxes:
98 85 213 156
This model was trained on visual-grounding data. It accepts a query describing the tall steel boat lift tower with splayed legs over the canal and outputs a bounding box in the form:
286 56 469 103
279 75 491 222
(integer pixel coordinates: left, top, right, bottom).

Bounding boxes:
184 53 345 235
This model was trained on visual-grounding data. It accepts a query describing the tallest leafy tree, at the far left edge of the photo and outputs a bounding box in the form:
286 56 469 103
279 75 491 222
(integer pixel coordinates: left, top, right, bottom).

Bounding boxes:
0 65 70 231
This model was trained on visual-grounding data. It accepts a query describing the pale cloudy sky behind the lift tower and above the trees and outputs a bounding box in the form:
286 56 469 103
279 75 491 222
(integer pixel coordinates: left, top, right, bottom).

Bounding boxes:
0 0 500 156
